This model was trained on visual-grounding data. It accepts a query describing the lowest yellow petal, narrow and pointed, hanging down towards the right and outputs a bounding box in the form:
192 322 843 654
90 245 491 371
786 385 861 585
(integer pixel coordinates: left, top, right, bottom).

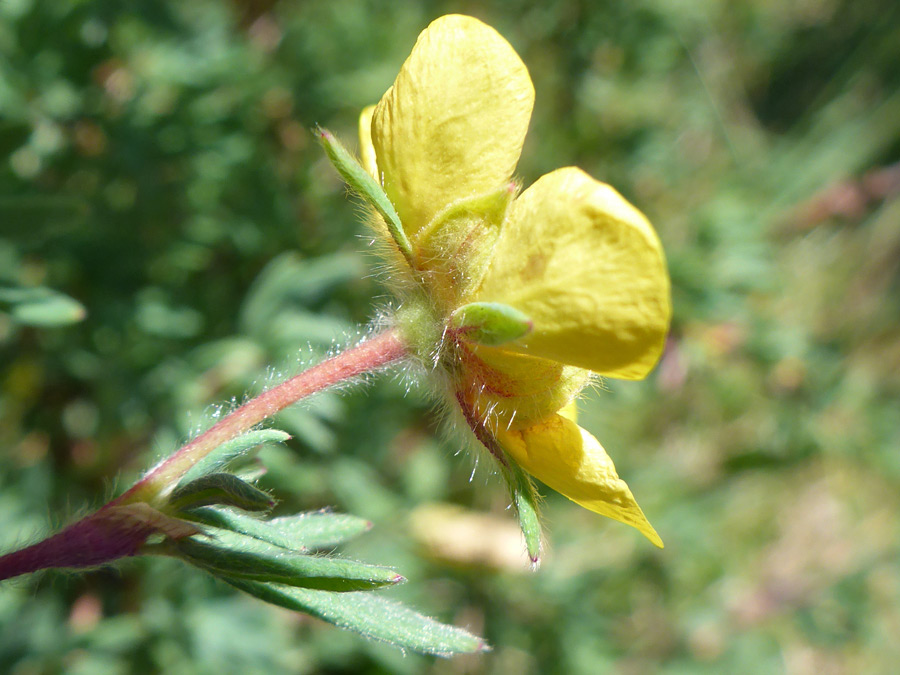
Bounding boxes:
497 415 663 548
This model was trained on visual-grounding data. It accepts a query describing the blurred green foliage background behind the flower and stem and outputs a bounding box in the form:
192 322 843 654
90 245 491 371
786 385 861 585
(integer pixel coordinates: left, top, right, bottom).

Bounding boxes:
0 0 900 675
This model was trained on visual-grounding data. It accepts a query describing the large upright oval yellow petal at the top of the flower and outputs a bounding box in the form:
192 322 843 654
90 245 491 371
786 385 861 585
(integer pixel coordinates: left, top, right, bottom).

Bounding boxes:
372 15 534 236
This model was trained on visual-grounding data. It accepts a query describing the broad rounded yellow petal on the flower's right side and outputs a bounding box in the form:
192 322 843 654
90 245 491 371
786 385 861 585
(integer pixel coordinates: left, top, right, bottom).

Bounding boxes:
473 167 671 379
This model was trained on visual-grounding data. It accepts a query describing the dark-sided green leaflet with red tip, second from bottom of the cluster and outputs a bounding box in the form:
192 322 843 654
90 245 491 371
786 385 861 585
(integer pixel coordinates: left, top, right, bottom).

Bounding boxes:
171 529 405 592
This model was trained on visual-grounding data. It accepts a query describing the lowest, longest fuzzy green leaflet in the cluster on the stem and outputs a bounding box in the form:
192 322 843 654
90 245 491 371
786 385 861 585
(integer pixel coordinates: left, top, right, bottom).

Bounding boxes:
225 579 490 656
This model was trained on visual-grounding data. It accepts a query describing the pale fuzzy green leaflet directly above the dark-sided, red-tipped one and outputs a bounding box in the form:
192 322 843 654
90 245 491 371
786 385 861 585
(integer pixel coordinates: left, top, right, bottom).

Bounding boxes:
184 508 372 551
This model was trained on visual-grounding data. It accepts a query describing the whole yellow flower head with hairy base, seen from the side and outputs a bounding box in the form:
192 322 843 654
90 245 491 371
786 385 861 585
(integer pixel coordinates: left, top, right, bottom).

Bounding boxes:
360 15 671 546
